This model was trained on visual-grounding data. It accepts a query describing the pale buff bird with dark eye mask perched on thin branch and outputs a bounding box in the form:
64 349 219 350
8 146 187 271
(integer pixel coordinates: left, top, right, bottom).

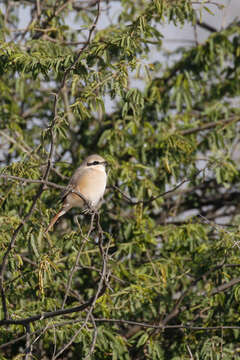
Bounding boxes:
45 154 107 233
